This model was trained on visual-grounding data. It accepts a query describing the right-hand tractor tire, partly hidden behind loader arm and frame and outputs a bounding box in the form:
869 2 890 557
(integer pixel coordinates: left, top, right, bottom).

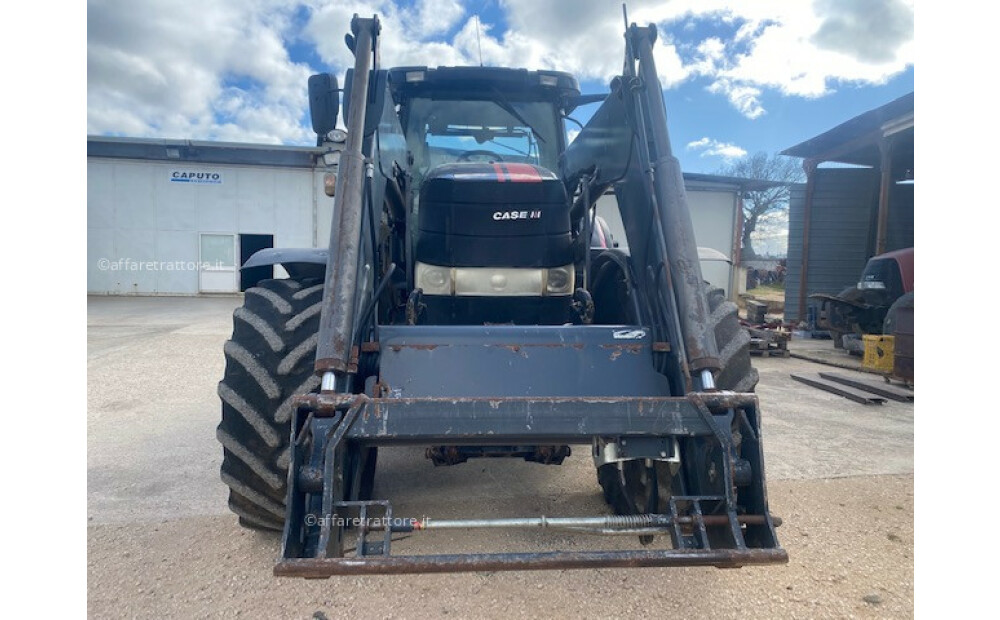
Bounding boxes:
597 282 759 514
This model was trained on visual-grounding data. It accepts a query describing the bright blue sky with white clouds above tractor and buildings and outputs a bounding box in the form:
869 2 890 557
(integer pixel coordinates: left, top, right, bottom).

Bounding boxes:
87 0 914 172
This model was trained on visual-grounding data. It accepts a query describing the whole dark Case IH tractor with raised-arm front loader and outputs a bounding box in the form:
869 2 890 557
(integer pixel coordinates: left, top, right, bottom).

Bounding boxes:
218 10 788 578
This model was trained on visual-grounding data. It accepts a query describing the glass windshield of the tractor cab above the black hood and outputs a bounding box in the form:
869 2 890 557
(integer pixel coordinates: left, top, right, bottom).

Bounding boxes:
406 94 560 177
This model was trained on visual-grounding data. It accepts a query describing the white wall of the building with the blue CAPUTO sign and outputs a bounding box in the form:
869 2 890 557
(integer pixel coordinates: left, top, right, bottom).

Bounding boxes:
87 158 324 295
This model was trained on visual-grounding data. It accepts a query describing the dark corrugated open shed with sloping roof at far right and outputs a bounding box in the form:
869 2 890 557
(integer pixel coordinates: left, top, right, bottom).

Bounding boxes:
782 93 914 322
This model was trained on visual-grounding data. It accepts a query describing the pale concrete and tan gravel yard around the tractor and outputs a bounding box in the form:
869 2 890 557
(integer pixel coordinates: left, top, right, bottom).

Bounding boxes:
87 298 913 618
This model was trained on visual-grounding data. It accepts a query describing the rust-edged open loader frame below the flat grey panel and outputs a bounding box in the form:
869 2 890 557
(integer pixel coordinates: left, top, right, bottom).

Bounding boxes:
274 392 788 578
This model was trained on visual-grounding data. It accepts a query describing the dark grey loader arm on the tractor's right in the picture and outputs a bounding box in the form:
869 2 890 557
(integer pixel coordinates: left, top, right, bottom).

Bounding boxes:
563 24 720 394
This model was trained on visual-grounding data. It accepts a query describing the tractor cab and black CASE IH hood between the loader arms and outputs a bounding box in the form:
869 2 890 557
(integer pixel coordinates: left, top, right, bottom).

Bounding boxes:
389 67 579 325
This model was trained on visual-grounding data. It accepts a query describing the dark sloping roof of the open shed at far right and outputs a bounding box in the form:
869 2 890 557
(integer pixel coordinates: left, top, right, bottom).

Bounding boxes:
781 93 913 166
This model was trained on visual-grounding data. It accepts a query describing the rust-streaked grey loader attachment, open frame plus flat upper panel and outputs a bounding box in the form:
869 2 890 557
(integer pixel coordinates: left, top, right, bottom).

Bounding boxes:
274 325 787 577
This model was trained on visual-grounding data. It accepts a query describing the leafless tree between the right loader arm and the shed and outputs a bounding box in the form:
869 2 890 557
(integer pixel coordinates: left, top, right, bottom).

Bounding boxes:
719 151 805 259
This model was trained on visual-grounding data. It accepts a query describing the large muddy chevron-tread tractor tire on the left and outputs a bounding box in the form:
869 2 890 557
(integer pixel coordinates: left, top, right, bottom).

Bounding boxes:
216 280 323 530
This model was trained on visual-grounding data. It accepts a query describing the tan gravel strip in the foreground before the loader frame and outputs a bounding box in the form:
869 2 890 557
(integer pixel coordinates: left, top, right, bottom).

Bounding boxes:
87 476 913 618
